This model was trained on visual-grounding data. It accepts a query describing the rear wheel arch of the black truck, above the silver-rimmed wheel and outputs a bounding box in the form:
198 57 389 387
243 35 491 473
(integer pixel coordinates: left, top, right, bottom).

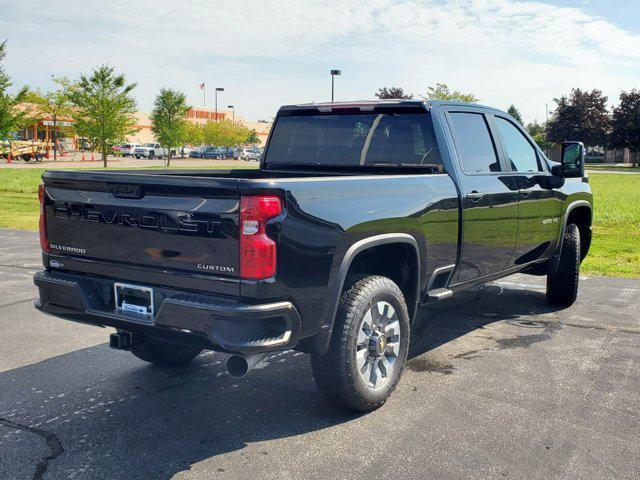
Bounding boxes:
313 233 422 353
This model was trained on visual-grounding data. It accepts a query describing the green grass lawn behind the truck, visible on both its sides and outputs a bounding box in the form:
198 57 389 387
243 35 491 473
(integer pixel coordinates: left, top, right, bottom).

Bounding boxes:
0 167 640 278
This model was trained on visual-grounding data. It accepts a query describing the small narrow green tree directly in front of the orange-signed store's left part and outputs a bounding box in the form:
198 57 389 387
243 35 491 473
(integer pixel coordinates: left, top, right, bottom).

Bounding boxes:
151 88 191 166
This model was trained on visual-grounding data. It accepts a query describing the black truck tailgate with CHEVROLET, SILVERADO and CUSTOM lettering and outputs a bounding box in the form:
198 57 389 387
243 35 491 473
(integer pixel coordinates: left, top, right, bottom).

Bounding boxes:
43 172 239 294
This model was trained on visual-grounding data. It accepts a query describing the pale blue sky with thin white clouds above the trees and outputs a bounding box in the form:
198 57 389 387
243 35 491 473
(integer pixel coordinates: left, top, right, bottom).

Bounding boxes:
0 0 640 121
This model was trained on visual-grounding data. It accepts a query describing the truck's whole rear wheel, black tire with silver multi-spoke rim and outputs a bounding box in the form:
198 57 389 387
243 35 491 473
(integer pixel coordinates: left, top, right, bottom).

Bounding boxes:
311 275 409 412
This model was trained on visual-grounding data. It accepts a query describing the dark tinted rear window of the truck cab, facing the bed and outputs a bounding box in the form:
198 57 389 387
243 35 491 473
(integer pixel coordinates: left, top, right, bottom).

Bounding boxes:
265 110 441 167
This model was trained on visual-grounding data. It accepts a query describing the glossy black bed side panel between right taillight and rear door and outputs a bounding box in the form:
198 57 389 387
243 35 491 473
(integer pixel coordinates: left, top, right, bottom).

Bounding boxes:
239 174 459 337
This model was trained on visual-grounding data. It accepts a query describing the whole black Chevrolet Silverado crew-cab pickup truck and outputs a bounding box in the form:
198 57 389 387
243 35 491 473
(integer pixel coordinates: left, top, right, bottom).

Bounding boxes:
34 101 592 411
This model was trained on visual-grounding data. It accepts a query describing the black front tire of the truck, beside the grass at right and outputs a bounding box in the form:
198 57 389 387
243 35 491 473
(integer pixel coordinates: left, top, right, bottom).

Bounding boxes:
547 223 580 307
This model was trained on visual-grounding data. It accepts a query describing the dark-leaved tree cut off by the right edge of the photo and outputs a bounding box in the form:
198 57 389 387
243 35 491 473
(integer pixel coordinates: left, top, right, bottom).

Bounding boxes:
610 89 640 165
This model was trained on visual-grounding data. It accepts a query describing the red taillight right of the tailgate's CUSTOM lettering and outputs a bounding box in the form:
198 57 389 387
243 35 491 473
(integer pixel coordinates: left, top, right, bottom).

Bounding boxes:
240 196 282 280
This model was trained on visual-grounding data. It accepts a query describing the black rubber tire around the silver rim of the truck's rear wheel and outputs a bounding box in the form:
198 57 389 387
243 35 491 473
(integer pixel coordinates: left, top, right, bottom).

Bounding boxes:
311 275 409 412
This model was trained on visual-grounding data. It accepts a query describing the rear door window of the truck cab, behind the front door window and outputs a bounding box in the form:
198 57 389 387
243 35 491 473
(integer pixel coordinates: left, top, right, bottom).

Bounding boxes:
449 112 500 173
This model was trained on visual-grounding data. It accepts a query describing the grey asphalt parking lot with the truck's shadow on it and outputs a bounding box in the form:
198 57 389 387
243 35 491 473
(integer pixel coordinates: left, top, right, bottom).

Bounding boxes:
0 230 640 479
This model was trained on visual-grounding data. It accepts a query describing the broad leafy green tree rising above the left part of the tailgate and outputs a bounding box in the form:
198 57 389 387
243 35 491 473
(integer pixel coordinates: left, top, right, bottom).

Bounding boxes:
70 65 136 167
